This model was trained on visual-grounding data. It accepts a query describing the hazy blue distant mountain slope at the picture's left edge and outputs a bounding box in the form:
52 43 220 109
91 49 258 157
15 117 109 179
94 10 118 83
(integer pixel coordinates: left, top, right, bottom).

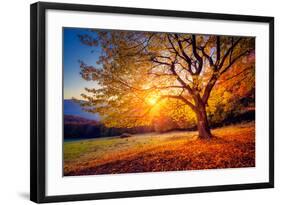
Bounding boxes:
64 99 100 121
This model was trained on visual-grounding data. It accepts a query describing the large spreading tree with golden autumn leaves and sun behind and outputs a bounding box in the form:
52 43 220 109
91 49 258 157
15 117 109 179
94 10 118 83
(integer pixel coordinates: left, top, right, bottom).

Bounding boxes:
76 31 255 139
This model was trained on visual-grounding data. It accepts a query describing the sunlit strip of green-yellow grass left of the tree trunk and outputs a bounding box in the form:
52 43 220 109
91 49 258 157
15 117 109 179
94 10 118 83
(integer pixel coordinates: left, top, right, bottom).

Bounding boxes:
64 131 196 162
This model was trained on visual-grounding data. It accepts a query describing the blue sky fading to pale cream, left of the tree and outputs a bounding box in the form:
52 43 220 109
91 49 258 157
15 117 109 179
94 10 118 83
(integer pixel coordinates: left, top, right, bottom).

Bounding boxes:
63 28 101 99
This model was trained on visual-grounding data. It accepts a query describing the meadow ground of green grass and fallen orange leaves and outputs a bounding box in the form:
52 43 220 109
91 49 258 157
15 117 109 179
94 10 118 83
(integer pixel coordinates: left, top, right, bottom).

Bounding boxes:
64 122 255 176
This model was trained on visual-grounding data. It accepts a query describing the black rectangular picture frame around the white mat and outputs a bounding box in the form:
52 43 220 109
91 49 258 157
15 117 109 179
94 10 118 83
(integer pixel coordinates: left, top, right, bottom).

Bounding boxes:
30 2 274 203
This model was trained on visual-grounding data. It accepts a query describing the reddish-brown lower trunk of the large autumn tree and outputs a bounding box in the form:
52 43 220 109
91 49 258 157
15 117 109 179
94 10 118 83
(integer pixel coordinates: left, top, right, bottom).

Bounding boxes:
196 105 213 139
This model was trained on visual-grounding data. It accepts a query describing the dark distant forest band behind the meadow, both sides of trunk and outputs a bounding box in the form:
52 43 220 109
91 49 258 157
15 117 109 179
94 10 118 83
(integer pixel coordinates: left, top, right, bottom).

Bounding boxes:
64 110 255 139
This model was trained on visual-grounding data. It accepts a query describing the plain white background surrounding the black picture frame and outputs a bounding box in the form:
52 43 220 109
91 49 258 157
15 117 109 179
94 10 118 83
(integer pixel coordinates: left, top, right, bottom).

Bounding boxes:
0 0 276 205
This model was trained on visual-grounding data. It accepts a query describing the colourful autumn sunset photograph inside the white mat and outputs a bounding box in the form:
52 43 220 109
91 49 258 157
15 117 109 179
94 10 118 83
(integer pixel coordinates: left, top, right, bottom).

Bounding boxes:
62 27 256 176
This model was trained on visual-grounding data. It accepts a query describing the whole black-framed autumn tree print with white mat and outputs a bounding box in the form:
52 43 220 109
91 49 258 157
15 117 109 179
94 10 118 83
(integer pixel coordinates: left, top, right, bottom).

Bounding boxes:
30 2 274 203
